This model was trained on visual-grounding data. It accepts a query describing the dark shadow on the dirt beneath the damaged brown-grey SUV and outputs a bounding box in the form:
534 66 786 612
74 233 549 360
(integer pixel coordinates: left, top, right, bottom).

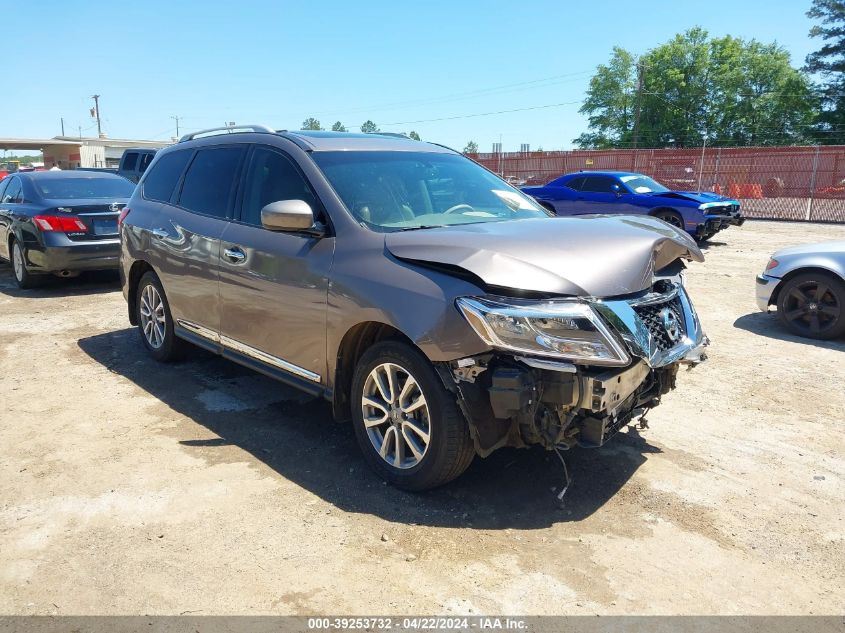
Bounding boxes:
79 329 660 529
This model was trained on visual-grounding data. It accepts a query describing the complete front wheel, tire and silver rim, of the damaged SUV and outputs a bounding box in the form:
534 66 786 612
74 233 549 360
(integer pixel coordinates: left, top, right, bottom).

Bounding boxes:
351 341 475 491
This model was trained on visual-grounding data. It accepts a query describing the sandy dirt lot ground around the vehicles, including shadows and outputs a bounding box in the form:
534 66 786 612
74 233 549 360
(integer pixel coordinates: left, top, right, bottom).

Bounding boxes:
0 222 845 615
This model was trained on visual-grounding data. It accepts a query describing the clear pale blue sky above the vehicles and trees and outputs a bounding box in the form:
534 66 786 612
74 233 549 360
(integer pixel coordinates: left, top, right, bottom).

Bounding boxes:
0 0 818 151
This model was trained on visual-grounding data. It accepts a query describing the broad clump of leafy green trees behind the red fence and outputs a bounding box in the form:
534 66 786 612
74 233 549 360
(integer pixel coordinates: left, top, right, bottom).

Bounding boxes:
575 27 814 148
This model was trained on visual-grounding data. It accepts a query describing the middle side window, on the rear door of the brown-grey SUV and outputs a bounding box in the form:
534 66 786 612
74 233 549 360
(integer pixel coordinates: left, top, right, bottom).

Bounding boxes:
179 145 244 218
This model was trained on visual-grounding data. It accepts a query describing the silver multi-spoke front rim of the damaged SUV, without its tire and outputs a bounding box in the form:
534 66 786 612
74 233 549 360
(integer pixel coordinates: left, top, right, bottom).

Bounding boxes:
361 363 431 469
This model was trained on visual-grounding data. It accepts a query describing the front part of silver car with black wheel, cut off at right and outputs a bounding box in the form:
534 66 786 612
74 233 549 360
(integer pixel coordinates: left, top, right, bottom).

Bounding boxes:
757 242 845 339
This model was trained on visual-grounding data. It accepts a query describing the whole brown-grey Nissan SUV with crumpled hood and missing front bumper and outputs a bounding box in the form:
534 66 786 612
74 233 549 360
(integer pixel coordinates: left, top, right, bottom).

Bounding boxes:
121 126 707 490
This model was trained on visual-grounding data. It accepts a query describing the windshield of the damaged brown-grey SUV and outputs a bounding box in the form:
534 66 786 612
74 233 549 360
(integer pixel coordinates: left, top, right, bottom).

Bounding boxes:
312 152 549 232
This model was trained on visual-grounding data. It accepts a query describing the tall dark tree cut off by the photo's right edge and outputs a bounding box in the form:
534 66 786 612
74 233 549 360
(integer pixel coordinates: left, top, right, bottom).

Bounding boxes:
804 0 845 143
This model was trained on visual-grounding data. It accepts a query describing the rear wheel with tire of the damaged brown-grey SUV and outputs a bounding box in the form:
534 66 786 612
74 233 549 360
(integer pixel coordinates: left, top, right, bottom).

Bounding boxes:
135 271 186 363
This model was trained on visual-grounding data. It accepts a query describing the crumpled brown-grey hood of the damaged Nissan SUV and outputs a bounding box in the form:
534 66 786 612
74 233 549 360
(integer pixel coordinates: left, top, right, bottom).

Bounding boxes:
385 215 704 297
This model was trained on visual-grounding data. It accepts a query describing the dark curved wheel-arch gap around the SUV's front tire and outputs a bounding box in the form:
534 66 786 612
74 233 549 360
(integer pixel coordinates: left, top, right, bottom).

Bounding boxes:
332 321 418 420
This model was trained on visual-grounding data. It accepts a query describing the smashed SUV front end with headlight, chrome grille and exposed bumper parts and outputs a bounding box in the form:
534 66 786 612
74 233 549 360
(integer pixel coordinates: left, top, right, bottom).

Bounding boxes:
443 275 709 456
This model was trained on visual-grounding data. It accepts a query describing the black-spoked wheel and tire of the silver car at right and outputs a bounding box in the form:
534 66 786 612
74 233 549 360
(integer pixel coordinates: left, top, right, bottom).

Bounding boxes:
777 272 845 340
